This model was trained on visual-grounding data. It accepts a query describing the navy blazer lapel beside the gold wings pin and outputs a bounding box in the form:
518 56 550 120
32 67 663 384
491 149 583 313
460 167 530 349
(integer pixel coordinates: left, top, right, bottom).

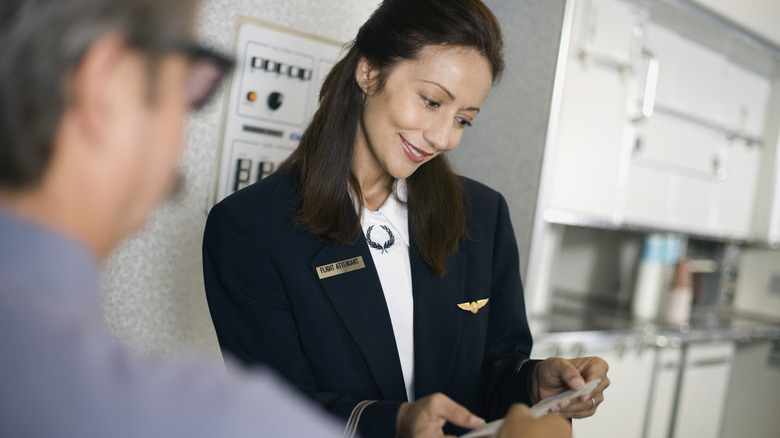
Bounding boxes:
409 234 467 398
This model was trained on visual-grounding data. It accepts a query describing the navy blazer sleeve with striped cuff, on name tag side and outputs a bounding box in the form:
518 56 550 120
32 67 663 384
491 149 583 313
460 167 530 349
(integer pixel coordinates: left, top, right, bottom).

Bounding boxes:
203 203 401 437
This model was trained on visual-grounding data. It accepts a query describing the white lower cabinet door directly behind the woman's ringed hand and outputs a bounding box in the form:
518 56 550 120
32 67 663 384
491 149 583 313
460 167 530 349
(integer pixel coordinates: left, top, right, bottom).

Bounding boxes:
572 347 656 438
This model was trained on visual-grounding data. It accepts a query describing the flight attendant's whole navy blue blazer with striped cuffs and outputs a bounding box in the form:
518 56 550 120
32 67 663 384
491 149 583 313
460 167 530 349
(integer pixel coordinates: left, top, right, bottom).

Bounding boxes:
203 171 536 437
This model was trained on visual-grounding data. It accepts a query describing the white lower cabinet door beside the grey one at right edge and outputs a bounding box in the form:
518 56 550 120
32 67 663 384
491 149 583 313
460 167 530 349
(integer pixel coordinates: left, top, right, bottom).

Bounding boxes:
672 342 734 438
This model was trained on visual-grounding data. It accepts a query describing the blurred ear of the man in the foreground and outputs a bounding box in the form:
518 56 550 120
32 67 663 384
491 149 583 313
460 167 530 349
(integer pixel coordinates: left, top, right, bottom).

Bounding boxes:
65 34 128 144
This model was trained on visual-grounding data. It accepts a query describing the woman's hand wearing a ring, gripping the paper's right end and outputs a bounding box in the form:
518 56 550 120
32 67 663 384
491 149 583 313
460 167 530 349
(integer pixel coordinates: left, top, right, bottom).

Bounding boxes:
532 357 609 418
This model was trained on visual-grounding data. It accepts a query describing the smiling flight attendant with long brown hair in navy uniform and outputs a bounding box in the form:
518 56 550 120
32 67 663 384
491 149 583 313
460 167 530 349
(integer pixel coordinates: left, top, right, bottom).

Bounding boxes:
203 0 609 437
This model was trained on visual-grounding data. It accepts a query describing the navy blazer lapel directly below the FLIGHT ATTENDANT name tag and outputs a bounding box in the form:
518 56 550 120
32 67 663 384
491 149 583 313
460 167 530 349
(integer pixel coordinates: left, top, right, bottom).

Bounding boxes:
311 239 406 400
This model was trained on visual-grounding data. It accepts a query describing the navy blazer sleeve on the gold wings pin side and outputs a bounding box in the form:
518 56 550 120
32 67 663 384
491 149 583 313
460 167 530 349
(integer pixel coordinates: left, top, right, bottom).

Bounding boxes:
480 194 539 420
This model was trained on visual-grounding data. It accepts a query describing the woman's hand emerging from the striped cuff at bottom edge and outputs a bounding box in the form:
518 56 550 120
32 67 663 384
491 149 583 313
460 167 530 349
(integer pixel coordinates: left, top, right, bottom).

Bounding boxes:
395 393 485 438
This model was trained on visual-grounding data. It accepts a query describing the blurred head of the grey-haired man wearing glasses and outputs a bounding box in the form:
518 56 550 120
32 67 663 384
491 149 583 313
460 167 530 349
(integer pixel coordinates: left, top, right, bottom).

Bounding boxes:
0 0 228 256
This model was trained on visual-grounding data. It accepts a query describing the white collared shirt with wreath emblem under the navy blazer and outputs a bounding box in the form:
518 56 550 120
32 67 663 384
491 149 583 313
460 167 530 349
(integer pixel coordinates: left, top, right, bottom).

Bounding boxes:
350 179 414 401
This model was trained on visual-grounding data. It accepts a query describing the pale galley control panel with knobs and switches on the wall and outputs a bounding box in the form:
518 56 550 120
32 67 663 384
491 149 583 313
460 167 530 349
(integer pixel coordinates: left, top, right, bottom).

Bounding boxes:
208 16 343 208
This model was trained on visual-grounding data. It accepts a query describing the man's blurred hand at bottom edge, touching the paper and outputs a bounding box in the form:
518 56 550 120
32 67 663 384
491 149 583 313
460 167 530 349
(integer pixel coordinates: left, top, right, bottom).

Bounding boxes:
498 404 571 438
